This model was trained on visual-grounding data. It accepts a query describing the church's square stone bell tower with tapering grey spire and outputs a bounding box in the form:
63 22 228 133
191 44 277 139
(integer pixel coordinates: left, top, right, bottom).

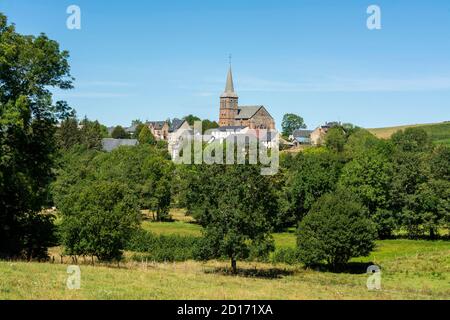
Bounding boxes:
219 63 239 127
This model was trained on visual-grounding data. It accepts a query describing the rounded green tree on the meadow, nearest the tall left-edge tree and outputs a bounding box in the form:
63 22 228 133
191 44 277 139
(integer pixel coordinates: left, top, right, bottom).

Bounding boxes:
57 181 140 261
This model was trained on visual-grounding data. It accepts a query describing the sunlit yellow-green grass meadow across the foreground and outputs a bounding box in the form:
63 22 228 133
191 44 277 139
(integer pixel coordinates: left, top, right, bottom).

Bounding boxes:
0 218 450 300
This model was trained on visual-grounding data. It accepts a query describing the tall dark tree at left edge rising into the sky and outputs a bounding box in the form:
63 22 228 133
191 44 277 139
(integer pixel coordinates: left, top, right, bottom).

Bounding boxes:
0 13 73 259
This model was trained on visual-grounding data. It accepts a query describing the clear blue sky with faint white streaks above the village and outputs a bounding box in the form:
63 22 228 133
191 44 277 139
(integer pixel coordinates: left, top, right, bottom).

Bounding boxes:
0 0 450 128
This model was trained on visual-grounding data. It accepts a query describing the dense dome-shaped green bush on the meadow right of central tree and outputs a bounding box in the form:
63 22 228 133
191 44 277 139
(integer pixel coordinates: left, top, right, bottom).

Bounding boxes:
297 190 377 269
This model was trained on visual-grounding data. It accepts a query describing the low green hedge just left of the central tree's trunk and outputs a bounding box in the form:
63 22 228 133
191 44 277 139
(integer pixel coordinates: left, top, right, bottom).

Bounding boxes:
126 229 201 262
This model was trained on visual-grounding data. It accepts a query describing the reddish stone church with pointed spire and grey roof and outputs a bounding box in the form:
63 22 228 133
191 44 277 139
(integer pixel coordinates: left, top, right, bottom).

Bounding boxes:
219 66 275 130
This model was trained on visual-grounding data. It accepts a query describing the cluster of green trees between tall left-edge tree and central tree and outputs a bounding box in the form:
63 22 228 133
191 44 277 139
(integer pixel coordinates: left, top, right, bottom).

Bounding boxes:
52 144 173 260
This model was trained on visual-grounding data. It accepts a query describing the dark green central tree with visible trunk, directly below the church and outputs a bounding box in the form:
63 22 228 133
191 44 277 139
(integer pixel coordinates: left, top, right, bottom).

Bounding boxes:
192 165 276 273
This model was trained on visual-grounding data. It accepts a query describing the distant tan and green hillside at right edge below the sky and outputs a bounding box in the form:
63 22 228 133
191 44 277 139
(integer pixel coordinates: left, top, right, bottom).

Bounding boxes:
367 121 450 146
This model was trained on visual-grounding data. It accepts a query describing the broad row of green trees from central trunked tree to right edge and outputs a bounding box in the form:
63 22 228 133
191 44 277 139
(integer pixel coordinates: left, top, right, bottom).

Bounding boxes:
177 125 450 269
